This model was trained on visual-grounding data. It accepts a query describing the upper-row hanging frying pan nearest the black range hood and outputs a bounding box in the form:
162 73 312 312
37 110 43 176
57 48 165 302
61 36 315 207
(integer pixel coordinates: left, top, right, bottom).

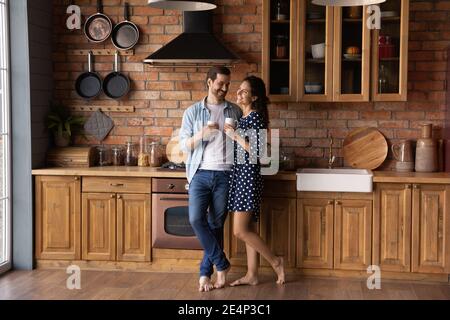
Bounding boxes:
111 2 139 50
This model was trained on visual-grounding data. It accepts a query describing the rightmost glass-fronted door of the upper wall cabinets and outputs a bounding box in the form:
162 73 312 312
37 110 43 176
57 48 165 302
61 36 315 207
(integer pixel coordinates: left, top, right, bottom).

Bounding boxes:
372 0 409 101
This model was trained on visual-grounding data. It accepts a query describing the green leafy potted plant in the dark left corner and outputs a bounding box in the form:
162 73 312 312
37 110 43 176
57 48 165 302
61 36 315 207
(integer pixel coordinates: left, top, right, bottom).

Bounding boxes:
47 104 85 147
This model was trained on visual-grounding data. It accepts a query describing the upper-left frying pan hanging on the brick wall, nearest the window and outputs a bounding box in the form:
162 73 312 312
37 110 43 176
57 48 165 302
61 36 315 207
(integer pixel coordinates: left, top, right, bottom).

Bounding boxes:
84 0 112 42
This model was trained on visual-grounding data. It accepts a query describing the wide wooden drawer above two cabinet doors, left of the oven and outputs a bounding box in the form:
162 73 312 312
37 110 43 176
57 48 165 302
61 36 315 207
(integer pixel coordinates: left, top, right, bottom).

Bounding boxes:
82 177 151 193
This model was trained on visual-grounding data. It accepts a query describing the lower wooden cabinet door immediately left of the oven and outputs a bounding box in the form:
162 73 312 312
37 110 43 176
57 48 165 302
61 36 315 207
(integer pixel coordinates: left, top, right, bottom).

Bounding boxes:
117 194 151 261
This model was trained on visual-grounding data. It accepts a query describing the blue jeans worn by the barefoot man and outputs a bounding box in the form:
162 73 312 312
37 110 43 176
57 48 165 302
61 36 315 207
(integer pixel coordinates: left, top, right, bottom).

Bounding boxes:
189 169 230 277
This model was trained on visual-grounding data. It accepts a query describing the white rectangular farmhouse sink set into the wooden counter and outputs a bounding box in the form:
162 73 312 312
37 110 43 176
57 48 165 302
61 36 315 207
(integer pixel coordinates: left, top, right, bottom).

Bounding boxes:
297 168 373 192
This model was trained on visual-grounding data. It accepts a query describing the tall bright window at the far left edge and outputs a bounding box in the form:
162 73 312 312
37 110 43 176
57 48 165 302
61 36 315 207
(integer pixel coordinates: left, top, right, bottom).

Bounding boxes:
0 0 11 273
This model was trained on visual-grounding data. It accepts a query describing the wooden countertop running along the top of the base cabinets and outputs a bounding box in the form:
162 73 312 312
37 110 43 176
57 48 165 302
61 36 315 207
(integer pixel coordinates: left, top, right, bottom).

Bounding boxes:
32 166 450 184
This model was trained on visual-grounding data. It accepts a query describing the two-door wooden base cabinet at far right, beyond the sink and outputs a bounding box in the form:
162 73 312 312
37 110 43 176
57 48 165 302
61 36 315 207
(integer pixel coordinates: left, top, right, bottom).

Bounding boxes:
373 183 450 273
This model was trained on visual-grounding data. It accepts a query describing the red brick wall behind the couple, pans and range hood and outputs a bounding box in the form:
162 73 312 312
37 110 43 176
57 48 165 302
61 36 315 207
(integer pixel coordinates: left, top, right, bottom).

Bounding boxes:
53 0 450 166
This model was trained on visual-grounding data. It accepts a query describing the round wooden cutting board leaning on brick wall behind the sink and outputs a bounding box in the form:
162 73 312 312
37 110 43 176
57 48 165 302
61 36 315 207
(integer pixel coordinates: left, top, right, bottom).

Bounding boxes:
343 127 388 170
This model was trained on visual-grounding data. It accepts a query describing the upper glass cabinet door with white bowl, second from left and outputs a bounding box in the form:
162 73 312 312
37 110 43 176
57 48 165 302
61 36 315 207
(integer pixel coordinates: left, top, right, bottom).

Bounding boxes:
298 0 334 101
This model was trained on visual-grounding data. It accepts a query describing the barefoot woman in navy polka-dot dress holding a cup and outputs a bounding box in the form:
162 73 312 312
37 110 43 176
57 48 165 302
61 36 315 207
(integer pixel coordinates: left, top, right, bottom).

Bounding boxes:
224 76 285 286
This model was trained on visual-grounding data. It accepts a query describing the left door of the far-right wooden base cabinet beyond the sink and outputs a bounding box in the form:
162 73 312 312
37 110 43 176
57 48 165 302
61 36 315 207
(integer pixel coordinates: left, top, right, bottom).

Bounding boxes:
373 183 411 272
